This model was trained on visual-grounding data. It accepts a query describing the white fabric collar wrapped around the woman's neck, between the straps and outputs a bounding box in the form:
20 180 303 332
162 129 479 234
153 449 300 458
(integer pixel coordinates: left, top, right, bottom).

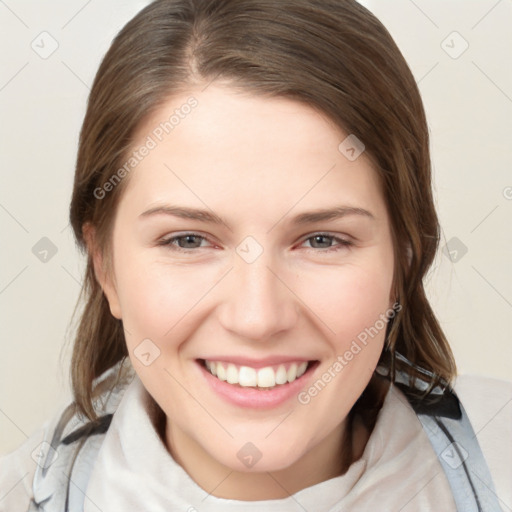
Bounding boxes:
84 376 451 512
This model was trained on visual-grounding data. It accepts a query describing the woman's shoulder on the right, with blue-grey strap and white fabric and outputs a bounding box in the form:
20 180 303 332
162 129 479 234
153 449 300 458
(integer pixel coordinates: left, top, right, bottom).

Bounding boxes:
386 372 512 510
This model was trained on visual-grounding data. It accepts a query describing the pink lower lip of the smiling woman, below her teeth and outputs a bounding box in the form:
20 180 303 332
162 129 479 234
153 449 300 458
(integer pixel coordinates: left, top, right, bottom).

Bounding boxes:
196 361 319 409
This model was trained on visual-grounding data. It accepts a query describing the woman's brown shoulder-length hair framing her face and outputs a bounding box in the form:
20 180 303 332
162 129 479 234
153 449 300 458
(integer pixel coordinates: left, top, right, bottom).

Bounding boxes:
70 0 455 419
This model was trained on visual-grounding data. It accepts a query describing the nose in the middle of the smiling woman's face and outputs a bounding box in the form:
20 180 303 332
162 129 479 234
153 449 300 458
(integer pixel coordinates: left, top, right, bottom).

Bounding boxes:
218 252 299 341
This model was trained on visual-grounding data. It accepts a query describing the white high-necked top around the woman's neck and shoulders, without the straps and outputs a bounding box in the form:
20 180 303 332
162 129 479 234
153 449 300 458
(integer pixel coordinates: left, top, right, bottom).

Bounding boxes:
0 377 512 512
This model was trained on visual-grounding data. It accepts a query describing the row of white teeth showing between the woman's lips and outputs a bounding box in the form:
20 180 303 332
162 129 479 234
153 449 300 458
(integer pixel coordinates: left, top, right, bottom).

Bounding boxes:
198 359 319 390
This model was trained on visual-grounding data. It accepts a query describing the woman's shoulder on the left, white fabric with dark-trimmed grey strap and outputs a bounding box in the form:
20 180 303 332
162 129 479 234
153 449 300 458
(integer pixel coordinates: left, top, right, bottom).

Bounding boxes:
0 360 134 512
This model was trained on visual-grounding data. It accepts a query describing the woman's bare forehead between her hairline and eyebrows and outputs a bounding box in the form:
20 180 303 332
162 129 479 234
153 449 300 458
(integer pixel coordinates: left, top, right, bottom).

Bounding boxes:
117 84 385 225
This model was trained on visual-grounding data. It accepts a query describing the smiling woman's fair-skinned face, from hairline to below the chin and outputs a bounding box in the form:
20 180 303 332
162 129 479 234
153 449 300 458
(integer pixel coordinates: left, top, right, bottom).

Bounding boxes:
99 83 394 480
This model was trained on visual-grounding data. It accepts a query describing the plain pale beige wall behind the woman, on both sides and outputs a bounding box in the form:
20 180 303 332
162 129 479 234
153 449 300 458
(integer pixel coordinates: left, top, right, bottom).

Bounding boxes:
0 0 512 453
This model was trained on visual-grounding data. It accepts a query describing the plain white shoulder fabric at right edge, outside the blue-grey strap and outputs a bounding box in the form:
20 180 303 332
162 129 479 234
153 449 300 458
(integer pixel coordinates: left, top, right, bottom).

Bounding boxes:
454 375 512 508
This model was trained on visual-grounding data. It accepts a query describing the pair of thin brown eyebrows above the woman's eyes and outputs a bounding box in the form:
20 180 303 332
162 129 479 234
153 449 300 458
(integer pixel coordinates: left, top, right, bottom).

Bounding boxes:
139 205 376 228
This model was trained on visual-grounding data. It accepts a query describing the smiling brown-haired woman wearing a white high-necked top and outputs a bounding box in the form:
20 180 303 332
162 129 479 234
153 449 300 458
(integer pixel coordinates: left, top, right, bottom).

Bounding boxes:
0 0 510 511
